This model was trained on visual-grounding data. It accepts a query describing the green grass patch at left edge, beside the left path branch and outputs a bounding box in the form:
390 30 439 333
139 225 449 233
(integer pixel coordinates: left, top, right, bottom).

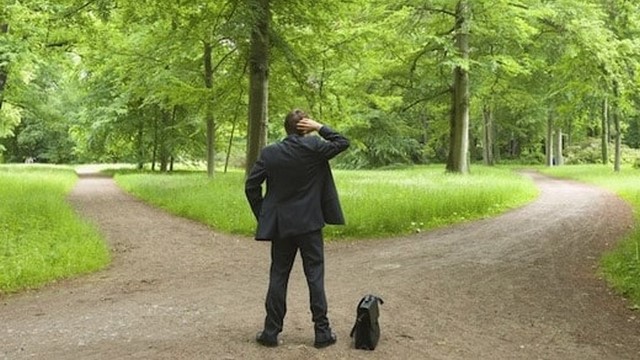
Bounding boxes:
0 166 110 293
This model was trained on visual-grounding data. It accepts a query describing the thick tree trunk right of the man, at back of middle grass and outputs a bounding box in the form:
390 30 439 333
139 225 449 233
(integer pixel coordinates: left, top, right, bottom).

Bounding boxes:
447 0 471 174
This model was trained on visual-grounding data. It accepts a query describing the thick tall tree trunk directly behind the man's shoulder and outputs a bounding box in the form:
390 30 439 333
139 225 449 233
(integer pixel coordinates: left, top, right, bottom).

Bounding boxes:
245 0 271 173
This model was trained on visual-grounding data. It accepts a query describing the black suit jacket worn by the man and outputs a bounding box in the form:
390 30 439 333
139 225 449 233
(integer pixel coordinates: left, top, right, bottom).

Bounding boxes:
245 126 349 240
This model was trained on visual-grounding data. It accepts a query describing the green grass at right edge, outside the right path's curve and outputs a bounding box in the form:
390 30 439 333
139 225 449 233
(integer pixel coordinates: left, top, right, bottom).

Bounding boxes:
543 165 640 308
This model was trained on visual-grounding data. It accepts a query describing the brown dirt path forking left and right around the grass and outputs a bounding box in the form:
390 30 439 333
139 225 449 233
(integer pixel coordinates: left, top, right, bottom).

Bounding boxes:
0 174 640 360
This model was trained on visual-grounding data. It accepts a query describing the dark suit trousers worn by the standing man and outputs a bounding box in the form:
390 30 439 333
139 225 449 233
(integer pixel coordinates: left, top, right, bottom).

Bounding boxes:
263 230 331 342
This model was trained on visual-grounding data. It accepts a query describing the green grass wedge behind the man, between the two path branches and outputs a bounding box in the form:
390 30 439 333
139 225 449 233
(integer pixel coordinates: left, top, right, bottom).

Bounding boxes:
116 165 538 239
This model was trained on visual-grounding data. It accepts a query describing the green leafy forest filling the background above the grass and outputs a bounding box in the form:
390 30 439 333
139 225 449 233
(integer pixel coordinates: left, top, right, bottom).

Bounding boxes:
0 0 640 176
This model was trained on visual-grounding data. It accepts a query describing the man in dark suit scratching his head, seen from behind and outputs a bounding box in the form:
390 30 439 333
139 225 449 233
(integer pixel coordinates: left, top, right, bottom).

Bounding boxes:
245 110 349 348
